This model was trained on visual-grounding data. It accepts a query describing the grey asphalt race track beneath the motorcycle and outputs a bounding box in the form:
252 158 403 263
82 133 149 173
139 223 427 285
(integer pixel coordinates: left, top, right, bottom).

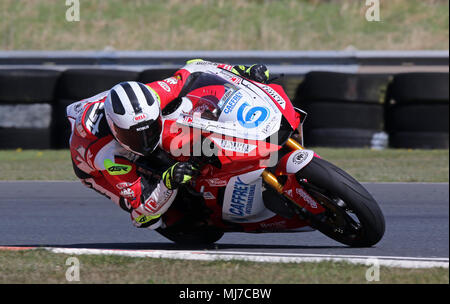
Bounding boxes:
0 181 449 258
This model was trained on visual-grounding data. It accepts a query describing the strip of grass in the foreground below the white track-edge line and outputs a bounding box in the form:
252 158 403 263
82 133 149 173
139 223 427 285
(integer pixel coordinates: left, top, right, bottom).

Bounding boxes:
0 250 449 284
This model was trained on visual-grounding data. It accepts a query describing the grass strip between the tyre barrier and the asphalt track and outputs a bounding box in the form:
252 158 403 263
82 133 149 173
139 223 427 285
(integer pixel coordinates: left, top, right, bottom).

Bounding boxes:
0 148 449 183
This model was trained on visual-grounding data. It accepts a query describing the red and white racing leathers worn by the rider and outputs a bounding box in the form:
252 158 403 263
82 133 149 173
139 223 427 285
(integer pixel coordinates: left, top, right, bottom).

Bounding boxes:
67 60 260 229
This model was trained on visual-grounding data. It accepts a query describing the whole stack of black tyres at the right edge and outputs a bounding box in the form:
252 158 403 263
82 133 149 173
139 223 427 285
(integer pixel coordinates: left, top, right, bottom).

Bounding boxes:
385 73 449 149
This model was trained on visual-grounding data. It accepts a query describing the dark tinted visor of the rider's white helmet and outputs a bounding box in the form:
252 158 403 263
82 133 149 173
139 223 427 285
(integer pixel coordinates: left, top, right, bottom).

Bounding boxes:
114 117 162 155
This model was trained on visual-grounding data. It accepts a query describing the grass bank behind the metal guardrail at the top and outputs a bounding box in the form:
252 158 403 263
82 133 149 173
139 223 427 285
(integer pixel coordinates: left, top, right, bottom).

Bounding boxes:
0 0 449 50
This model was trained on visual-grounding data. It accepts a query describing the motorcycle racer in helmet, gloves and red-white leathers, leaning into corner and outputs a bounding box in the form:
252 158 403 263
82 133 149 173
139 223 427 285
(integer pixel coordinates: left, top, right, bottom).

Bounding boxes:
66 59 269 229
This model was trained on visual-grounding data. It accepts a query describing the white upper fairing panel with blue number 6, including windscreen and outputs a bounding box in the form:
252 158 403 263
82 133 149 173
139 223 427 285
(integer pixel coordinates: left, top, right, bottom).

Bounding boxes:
177 71 293 140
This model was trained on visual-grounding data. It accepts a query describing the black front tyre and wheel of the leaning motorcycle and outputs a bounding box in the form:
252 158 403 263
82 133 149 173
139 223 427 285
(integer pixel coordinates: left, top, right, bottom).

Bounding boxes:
296 157 385 247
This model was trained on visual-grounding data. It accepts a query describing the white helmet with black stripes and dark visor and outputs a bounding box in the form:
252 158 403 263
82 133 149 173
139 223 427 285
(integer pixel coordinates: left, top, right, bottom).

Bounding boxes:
105 81 162 156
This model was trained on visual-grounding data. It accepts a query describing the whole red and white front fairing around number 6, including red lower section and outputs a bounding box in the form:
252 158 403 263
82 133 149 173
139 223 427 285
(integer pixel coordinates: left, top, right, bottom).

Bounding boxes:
163 71 299 170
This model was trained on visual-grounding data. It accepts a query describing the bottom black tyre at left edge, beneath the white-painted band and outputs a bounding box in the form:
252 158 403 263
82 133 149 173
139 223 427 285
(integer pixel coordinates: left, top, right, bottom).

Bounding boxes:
0 127 51 149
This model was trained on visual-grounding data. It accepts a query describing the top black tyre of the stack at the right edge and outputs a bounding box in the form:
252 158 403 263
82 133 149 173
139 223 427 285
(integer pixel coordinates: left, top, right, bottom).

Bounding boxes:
386 73 449 104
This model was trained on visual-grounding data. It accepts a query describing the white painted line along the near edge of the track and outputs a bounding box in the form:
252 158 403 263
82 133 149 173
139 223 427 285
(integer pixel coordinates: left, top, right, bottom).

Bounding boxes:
46 247 449 268
